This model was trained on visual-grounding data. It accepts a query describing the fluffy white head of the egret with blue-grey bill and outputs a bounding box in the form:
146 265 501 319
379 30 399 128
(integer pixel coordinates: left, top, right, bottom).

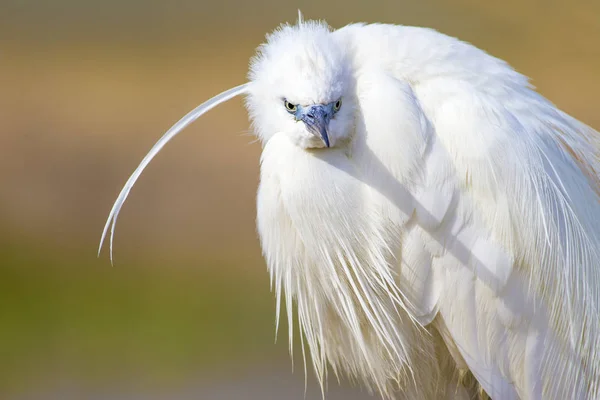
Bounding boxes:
246 21 355 149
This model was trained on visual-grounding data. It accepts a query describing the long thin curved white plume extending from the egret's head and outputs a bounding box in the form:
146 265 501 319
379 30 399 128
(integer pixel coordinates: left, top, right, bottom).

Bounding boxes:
98 83 249 264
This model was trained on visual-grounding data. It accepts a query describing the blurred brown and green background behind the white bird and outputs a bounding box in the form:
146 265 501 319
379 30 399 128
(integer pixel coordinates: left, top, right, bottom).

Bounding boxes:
0 0 600 400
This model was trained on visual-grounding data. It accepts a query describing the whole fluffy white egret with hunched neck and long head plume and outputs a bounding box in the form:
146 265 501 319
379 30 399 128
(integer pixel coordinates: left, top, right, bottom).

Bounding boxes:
99 14 600 400
